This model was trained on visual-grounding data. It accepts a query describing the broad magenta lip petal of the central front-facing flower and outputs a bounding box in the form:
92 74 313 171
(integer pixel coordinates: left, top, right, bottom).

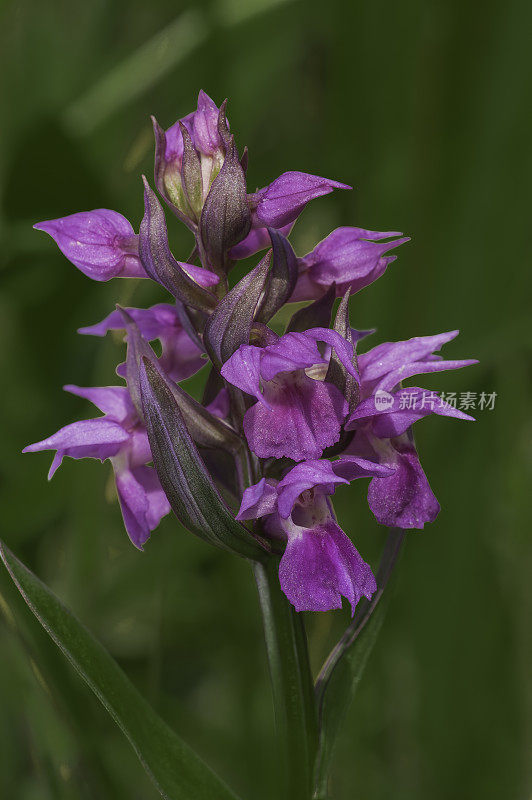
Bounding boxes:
244 373 348 461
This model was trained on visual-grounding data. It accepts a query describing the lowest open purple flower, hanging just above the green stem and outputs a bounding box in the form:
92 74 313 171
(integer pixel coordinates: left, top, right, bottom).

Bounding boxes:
237 456 393 614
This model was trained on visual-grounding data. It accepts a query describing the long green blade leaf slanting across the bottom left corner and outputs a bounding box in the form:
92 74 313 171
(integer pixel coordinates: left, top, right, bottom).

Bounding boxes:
0 541 241 800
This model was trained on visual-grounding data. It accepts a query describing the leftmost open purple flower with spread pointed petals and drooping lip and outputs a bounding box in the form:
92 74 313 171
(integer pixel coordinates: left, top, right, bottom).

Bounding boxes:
23 386 170 550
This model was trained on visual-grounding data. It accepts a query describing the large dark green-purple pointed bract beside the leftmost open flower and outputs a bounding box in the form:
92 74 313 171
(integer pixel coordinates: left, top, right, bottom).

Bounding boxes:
137 358 264 558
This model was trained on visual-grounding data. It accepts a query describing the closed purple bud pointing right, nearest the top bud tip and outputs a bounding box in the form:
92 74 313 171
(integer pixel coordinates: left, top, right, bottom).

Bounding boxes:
248 172 351 228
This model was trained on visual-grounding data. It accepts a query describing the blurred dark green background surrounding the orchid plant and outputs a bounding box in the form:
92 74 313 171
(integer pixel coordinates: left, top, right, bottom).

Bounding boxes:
0 0 532 800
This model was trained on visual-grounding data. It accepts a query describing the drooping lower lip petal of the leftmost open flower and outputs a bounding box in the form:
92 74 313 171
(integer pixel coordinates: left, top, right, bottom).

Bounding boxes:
116 467 170 550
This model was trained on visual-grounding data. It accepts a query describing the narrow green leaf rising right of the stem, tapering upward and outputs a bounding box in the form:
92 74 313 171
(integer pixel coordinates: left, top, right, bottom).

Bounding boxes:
313 528 405 800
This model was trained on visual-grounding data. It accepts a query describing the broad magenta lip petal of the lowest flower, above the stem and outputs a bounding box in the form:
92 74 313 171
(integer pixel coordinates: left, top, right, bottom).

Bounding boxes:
279 520 377 614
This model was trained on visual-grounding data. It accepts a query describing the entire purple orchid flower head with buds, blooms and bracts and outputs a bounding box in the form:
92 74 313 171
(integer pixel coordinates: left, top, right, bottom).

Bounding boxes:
26 92 475 611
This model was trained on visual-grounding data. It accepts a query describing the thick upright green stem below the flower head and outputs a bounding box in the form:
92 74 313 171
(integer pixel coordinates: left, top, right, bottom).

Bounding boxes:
254 557 317 800
